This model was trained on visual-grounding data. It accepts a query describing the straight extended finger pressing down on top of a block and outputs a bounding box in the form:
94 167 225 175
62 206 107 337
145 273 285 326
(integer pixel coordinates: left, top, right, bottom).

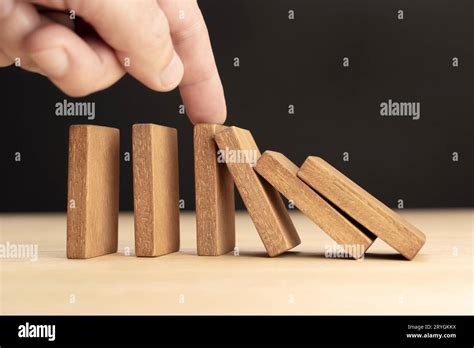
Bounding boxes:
158 0 227 123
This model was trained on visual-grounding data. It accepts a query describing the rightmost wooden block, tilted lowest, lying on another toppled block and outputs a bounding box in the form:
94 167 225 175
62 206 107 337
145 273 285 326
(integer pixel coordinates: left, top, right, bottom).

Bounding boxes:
298 157 425 260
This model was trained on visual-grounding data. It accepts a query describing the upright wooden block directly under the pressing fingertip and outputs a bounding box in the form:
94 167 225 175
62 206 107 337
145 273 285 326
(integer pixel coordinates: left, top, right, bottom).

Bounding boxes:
194 124 235 256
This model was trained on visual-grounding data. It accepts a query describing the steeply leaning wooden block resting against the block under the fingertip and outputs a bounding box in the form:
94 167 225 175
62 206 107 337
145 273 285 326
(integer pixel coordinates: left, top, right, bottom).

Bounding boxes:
215 127 300 256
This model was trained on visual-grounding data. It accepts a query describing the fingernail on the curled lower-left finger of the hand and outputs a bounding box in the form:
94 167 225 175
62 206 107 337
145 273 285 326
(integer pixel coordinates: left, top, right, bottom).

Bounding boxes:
30 47 69 78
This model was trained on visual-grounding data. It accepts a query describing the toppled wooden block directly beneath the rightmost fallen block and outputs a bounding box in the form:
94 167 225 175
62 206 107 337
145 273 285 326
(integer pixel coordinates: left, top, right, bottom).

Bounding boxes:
255 151 376 259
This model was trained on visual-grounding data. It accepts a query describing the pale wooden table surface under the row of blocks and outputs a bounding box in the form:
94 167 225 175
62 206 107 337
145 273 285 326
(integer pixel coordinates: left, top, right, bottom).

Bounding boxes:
0 209 474 314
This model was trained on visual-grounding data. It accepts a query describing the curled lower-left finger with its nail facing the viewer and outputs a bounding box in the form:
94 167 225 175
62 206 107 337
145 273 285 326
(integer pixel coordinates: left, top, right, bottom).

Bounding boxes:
25 23 125 97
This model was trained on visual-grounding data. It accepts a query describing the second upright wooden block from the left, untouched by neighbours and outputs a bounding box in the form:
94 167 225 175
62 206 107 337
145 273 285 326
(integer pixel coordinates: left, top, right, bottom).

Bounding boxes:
132 124 179 256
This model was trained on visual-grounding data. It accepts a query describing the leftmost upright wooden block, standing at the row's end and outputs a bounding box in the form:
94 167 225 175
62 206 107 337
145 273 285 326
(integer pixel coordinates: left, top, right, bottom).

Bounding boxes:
67 125 120 259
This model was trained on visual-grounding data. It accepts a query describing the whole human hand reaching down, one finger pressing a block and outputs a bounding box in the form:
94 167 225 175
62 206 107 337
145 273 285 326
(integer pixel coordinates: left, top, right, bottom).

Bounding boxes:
0 0 226 123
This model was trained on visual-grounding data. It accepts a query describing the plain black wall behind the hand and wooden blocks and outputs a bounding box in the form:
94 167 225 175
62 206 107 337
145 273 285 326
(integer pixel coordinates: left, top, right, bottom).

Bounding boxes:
0 0 474 211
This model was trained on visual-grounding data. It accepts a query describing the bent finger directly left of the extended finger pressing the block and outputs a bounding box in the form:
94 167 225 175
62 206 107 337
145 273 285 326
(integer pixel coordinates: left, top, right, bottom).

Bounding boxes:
28 0 184 91
